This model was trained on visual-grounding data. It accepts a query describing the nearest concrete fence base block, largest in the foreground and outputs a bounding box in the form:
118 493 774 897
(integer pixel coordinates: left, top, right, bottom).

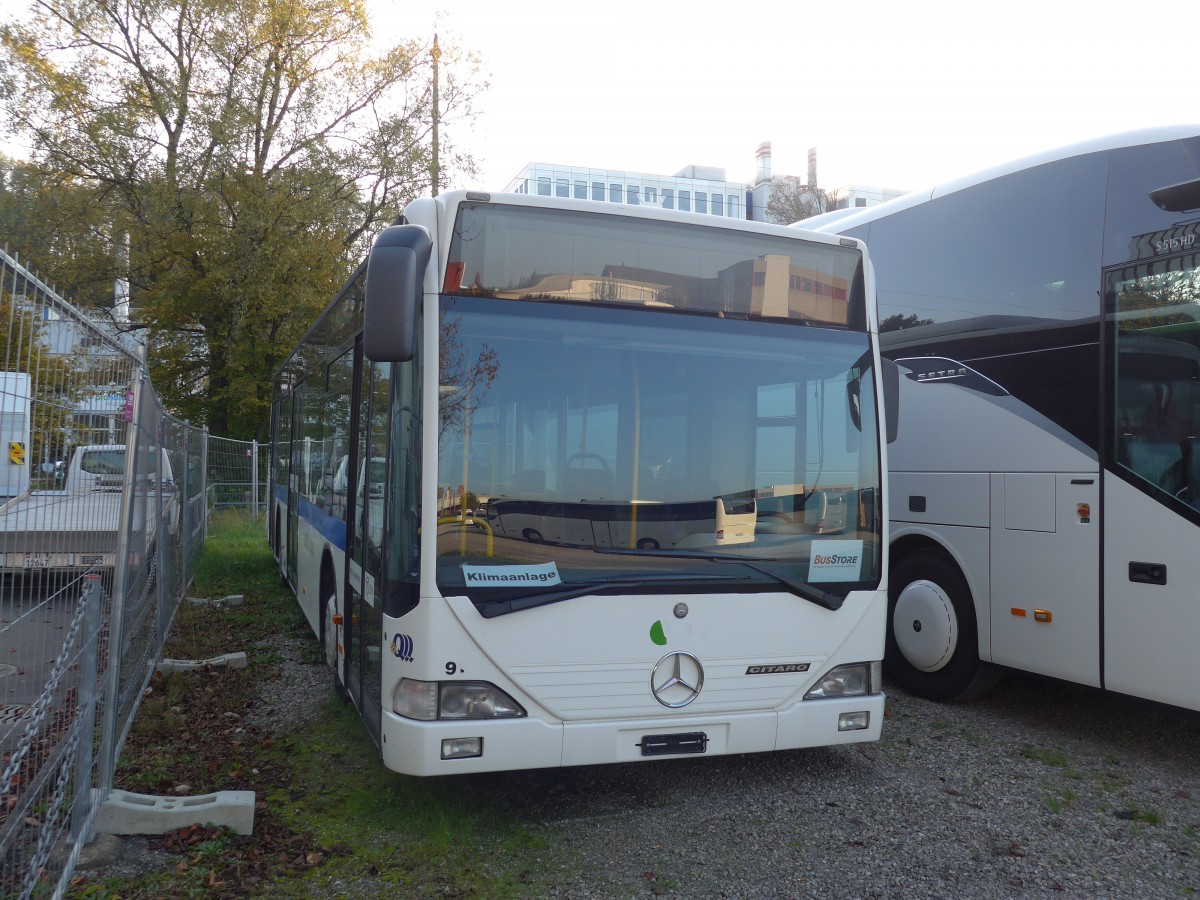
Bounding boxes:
92 791 254 834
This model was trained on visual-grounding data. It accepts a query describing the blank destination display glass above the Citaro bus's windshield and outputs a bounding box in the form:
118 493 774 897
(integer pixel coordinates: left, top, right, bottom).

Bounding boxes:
443 203 865 334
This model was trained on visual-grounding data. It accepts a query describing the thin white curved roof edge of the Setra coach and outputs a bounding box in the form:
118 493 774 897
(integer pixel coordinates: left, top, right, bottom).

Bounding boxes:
792 125 1200 234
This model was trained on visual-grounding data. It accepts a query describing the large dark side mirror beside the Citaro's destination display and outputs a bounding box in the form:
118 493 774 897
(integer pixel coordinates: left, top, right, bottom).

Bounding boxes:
362 224 433 362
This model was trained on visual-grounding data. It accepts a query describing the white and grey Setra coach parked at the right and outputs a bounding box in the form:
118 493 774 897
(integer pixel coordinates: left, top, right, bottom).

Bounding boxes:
799 126 1200 709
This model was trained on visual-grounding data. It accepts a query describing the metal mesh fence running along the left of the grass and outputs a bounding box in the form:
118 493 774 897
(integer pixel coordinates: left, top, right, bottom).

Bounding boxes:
0 243 211 898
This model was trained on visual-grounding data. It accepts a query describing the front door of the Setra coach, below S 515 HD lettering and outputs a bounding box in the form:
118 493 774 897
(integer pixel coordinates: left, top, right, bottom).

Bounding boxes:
1104 254 1200 709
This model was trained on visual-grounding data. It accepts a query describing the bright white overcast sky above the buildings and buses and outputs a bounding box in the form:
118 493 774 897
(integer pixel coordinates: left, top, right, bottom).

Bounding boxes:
367 0 1200 191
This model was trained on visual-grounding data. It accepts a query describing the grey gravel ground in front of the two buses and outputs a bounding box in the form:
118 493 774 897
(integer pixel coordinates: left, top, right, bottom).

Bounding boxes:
82 633 1200 899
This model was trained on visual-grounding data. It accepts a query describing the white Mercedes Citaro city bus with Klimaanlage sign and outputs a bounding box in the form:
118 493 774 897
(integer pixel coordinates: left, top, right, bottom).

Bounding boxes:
269 192 895 775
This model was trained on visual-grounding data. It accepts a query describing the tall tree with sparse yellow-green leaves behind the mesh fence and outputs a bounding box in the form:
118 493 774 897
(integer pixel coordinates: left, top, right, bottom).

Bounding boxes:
0 0 482 437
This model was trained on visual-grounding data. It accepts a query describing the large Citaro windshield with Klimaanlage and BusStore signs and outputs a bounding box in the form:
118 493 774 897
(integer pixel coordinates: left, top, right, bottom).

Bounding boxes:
437 296 881 612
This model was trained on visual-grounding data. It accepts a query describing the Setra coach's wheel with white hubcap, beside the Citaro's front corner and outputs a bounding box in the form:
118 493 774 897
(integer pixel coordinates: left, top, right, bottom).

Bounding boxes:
883 550 1000 702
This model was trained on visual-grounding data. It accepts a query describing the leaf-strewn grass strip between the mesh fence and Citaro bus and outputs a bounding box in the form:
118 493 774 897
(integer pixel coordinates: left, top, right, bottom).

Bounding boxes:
75 514 560 900
